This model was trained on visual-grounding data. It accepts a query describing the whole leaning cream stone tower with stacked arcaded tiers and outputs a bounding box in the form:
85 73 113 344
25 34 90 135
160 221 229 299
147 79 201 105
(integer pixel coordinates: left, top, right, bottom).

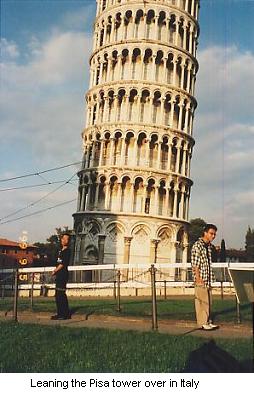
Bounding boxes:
73 0 199 264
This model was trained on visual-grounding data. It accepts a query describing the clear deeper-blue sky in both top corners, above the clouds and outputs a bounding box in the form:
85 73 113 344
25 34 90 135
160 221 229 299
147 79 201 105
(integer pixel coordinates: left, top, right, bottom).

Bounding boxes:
1 0 254 49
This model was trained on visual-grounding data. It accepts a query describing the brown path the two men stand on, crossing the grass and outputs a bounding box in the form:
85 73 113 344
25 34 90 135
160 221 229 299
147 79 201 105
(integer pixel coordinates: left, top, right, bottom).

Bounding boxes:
0 311 253 338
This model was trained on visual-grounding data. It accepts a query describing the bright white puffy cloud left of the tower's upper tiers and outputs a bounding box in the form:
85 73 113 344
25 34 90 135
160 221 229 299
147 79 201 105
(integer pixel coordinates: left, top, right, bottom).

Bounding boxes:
1 32 91 91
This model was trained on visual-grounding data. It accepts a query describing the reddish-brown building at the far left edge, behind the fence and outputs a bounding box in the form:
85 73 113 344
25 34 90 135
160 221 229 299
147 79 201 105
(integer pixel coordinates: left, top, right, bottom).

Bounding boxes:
0 238 37 268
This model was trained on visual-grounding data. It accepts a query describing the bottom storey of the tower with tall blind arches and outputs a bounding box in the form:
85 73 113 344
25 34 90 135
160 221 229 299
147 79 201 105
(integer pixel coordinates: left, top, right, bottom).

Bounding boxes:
73 211 188 264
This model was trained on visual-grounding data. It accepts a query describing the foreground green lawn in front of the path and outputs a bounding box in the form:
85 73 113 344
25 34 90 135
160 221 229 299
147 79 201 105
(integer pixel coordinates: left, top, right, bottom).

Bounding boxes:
0 321 253 373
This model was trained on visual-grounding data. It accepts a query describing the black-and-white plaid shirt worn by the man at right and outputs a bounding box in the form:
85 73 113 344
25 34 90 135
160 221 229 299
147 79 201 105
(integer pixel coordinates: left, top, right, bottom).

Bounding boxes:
191 238 215 287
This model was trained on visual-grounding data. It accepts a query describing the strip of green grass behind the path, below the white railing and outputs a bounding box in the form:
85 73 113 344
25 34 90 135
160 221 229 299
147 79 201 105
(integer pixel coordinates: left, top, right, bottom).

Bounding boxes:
0 296 253 323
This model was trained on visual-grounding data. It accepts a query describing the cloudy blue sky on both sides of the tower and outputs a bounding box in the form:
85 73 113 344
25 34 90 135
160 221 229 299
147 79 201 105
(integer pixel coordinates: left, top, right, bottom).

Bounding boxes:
0 0 254 248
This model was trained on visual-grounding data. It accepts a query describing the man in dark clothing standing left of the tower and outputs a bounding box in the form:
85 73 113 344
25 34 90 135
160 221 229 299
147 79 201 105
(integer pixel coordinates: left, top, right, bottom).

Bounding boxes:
51 234 71 320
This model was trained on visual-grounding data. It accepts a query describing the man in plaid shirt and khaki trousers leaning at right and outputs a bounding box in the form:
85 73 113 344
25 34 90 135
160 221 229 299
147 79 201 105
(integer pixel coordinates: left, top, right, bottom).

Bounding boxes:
191 224 218 330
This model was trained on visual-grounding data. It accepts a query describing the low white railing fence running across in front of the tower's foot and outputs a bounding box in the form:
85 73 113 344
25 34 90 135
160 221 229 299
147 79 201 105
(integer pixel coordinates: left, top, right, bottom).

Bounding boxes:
0 263 254 329
